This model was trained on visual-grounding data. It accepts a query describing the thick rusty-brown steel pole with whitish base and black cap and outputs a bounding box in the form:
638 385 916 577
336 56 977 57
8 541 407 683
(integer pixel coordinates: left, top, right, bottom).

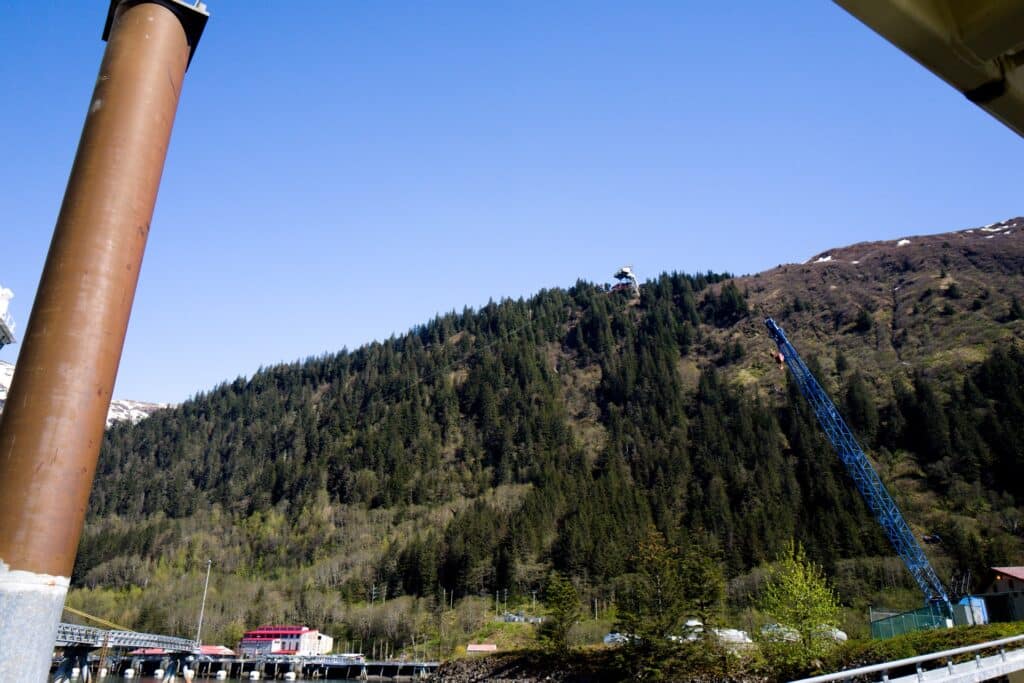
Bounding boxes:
0 0 207 683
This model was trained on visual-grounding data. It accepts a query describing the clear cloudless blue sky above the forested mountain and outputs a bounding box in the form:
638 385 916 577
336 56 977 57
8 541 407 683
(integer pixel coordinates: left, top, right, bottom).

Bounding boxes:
0 0 1024 401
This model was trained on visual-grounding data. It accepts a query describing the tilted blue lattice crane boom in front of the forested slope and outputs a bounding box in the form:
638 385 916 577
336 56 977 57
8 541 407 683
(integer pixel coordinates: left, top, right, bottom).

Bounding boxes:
765 317 952 614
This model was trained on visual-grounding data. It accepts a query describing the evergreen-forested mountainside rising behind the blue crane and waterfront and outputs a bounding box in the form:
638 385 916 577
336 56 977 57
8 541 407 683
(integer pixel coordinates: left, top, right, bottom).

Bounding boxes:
73 219 1024 640
